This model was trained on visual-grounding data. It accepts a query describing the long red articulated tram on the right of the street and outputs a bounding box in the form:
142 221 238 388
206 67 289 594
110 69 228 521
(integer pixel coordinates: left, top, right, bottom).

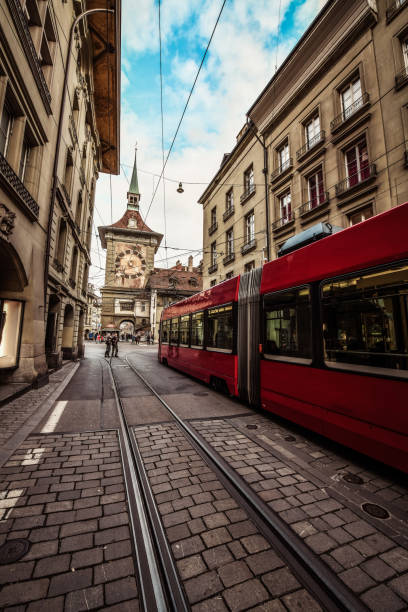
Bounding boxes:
159 203 408 472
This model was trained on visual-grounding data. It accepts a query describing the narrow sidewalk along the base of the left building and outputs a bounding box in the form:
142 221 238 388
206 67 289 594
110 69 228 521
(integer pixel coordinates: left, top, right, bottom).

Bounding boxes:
0 362 75 447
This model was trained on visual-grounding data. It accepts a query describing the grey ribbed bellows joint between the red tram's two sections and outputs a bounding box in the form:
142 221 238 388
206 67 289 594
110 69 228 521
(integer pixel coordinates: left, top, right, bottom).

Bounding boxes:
237 268 262 405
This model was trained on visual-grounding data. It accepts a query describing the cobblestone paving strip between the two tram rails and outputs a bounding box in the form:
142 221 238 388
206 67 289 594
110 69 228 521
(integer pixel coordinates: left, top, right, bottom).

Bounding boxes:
134 424 321 612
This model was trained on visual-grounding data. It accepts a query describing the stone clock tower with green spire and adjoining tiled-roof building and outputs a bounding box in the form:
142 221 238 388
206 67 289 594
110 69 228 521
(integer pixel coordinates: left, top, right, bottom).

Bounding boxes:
98 150 202 337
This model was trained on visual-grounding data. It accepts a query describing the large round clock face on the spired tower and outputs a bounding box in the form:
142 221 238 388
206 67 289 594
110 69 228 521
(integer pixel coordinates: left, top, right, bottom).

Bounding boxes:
114 243 146 288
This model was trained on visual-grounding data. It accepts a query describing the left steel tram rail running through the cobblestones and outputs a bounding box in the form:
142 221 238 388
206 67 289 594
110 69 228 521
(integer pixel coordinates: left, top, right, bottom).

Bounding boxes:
106 358 190 612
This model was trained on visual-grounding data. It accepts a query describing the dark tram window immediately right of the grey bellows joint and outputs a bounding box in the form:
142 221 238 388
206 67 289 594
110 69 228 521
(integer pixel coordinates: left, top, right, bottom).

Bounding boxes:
264 287 312 362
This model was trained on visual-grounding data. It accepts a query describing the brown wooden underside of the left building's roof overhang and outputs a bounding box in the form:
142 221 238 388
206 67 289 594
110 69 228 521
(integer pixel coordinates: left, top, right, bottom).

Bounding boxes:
86 0 122 174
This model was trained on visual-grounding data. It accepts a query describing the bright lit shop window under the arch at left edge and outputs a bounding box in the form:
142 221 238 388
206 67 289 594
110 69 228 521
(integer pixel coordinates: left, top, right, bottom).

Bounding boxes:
0 299 24 369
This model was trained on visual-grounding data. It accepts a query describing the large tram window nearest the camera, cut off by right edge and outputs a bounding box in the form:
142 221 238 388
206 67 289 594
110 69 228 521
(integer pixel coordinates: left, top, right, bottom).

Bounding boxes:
321 263 408 376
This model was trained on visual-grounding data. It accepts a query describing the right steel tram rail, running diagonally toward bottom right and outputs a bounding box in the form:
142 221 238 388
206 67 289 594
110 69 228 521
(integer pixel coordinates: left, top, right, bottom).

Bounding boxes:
126 356 368 612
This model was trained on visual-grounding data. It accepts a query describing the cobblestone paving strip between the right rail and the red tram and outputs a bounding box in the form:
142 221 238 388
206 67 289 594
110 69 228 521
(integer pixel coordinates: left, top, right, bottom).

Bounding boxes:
193 419 408 612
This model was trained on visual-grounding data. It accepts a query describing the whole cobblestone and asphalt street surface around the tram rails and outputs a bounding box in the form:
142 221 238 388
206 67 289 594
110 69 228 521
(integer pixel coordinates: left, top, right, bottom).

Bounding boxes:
0 345 408 612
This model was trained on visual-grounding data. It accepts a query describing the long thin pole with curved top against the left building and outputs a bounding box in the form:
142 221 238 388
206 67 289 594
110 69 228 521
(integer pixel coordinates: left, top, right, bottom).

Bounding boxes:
44 8 115 308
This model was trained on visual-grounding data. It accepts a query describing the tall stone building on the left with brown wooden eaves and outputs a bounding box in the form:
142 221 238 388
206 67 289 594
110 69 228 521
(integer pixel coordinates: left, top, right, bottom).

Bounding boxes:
0 0 121 384
